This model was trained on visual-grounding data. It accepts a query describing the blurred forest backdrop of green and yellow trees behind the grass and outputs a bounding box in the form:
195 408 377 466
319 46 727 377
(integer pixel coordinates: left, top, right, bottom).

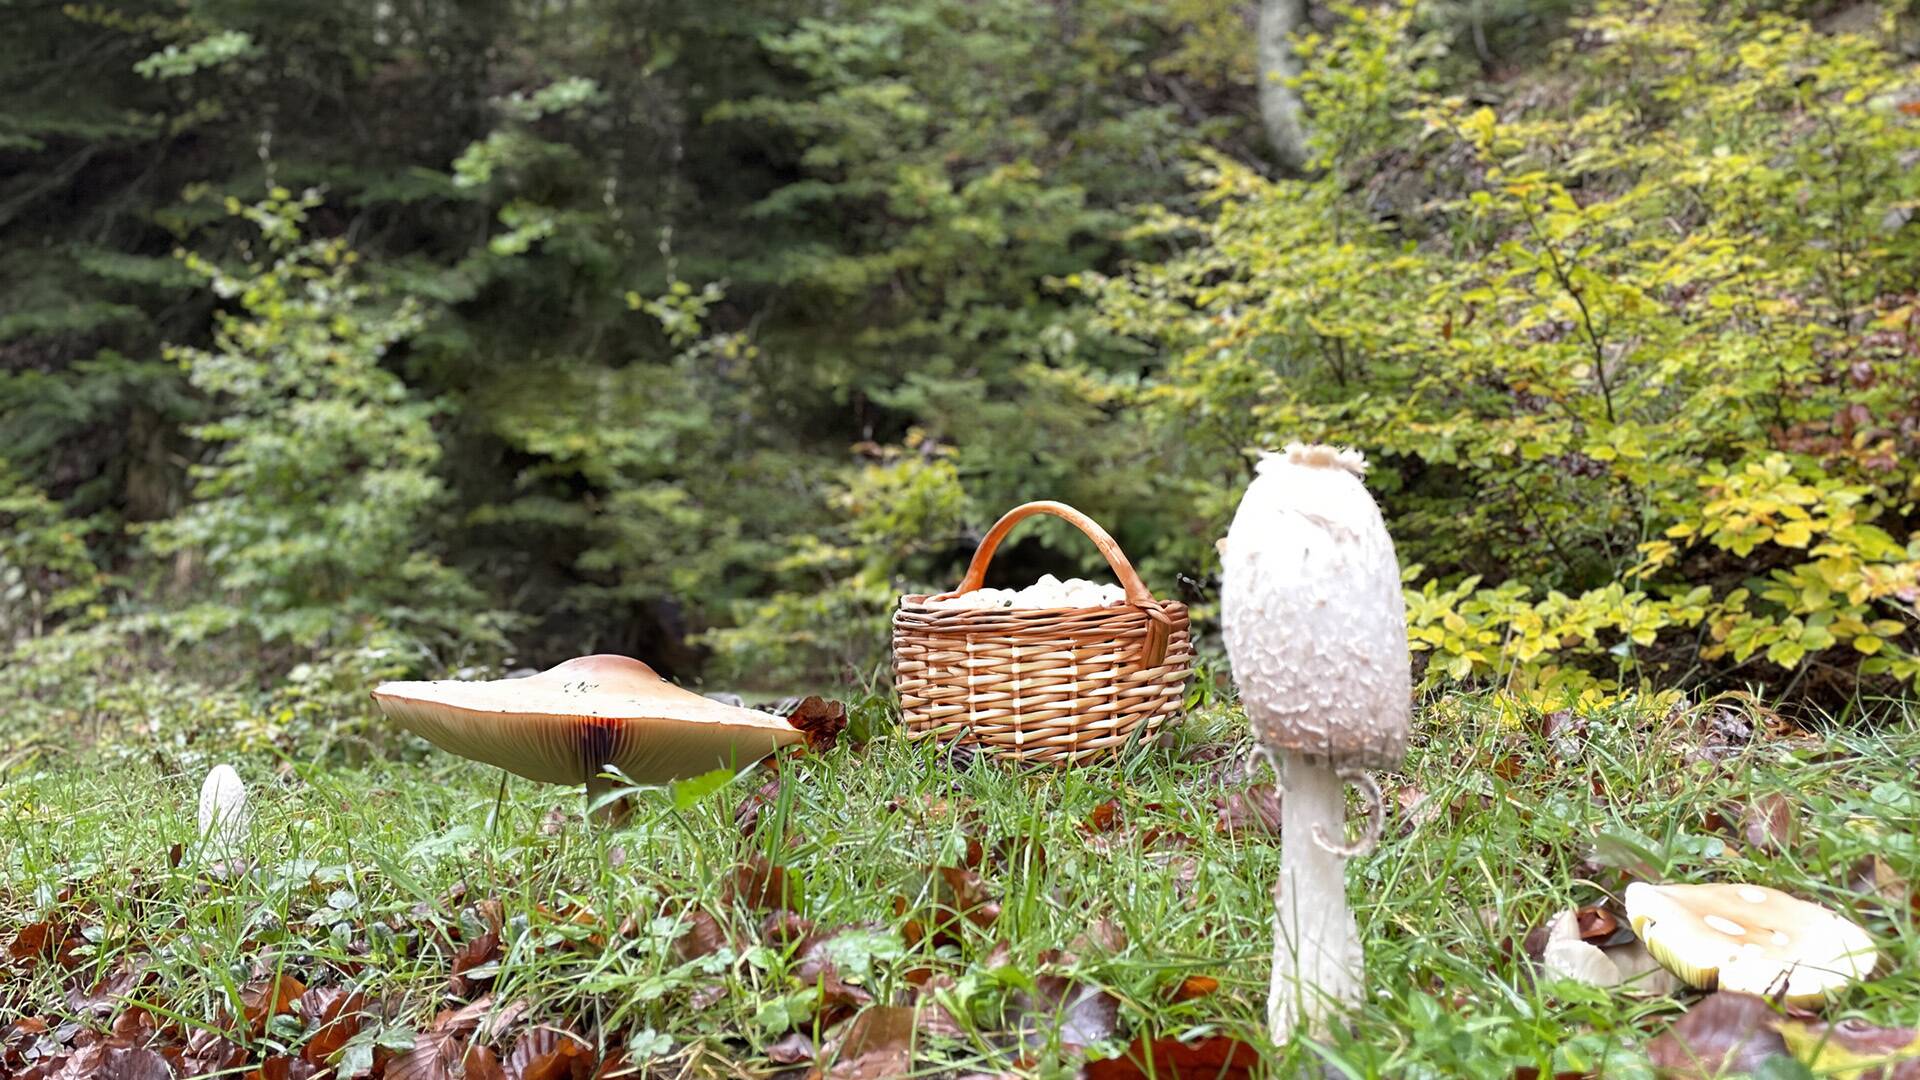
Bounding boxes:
0 0 1920 749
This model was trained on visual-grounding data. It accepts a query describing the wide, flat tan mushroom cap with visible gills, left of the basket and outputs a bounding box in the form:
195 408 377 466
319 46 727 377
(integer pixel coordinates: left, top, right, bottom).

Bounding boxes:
372 655 803 784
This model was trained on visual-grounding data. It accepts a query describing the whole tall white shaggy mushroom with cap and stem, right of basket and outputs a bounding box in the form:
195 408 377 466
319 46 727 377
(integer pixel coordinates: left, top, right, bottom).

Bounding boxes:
1221 444 1413 1043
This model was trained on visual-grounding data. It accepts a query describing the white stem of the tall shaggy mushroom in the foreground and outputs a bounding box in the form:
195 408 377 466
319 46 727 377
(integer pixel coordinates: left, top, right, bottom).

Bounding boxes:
1267 749 1365 1045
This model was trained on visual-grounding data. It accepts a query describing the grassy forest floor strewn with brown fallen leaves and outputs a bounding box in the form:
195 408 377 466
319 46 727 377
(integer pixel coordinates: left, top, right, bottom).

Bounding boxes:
0 698 1920 1080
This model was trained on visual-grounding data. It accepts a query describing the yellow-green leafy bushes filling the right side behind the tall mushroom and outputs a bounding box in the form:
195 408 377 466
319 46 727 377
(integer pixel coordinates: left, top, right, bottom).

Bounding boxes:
1096 6 1920 701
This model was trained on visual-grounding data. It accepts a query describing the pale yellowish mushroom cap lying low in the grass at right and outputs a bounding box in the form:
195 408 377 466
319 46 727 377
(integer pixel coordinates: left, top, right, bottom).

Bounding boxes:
1626 882 1880 1005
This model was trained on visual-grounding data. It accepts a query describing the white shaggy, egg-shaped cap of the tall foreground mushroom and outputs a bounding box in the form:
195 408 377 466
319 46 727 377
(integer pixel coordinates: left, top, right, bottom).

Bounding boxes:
1221 444 1413 769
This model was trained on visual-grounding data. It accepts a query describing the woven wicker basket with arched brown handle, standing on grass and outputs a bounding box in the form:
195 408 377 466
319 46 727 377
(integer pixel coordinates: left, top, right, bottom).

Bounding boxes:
893 502 1192 765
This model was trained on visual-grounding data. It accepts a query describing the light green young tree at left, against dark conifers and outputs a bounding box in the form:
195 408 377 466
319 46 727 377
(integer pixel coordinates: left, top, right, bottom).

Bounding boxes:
144 188 499 648
